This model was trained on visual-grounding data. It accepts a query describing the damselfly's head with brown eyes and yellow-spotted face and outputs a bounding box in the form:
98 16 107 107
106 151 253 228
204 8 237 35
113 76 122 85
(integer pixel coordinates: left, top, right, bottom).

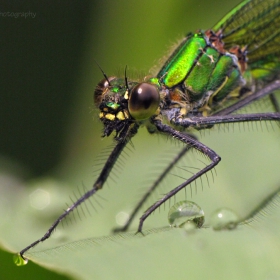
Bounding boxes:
94 77 160 136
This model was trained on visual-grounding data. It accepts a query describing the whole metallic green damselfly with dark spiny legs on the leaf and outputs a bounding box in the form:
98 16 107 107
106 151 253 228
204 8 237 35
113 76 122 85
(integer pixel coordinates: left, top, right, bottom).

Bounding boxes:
19 0 280 260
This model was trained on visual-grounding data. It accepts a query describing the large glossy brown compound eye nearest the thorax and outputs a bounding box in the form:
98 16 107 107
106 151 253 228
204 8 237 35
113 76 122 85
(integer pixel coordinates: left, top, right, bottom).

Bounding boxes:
128 83 160 120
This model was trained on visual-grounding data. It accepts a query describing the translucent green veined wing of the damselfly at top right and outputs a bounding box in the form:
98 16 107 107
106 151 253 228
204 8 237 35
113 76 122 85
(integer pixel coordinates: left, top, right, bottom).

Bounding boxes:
213 0 280 63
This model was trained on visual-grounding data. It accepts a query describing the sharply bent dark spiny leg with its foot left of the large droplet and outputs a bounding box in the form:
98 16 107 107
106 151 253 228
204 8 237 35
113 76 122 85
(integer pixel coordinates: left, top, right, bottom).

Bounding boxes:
137 120 221 232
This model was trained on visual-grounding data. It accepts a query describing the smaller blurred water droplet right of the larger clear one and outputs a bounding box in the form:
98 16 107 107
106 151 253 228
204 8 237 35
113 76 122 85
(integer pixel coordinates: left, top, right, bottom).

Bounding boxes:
210 208 239 230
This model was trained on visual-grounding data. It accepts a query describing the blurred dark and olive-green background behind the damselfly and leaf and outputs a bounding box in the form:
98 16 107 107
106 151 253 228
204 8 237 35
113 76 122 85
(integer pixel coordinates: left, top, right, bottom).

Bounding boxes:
0 0 278 279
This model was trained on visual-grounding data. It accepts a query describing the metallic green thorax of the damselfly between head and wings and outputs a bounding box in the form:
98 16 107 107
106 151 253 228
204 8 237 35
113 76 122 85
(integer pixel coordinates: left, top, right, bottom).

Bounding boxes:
157 32 244 112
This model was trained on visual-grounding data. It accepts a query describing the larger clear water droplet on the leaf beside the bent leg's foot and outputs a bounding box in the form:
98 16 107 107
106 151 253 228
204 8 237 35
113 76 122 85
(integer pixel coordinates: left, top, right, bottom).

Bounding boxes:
168 200 204 228
